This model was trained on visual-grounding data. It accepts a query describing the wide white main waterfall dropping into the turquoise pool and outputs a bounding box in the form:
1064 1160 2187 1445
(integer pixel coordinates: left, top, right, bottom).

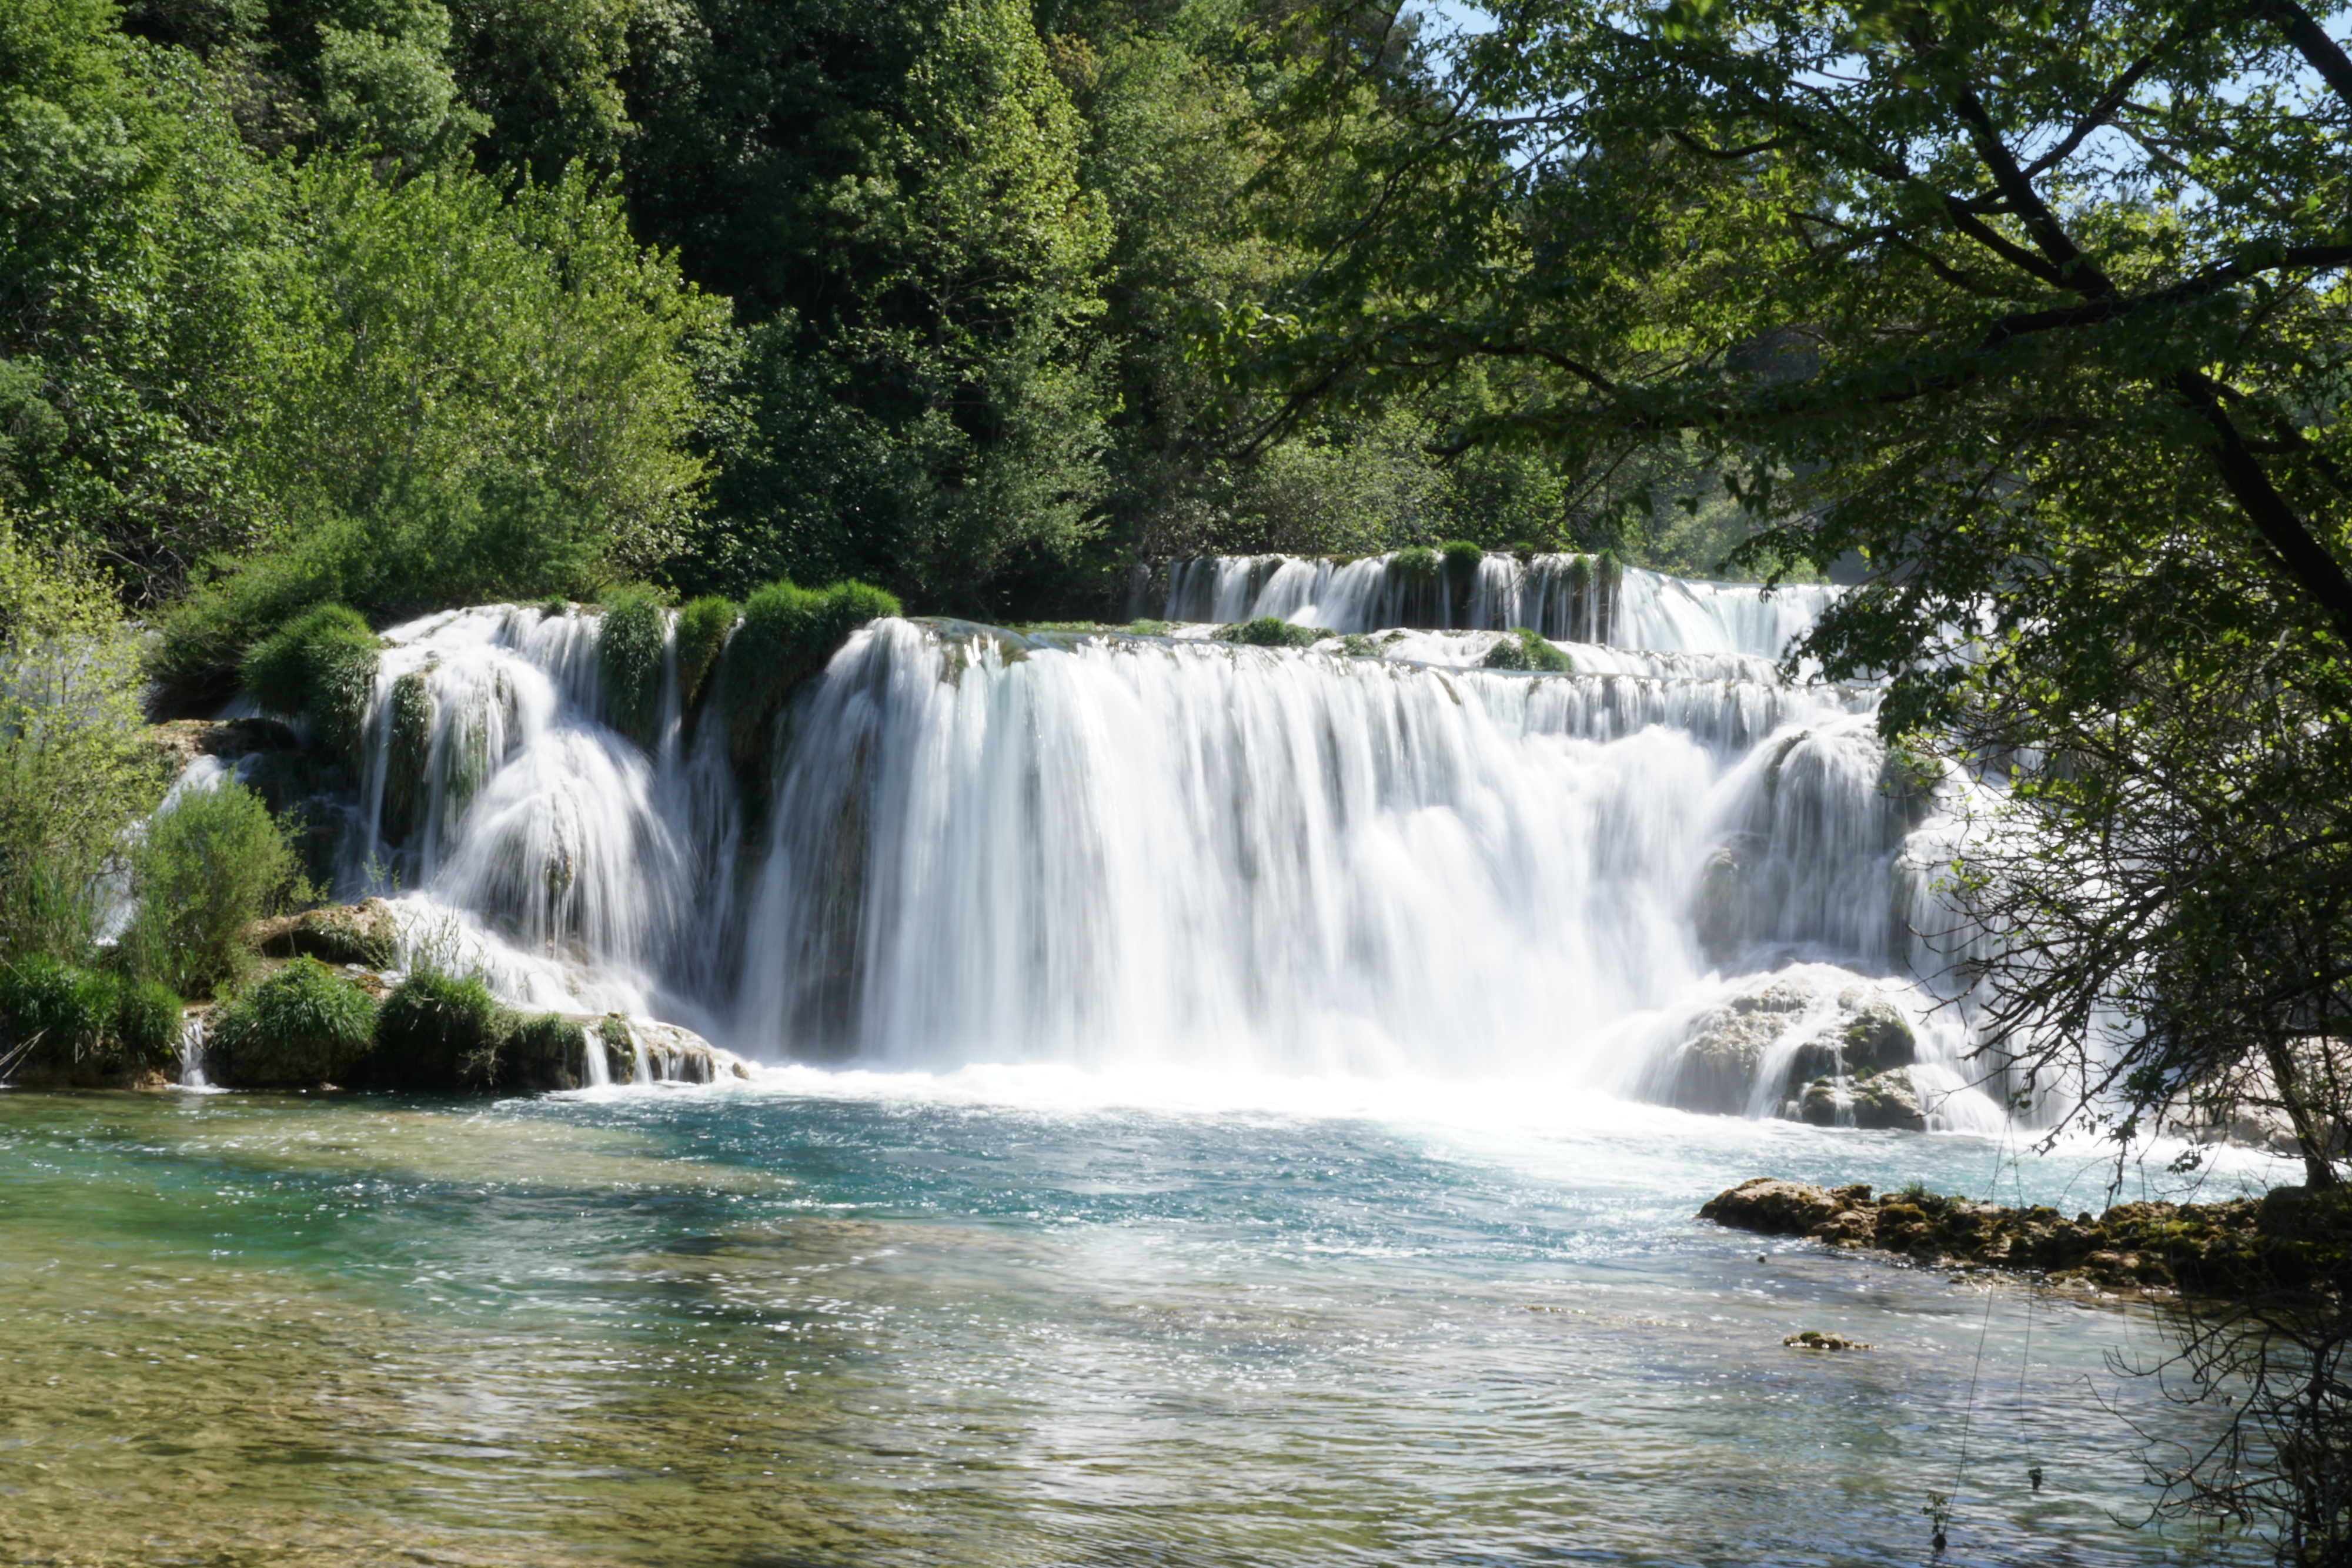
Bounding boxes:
258 557 1999 1128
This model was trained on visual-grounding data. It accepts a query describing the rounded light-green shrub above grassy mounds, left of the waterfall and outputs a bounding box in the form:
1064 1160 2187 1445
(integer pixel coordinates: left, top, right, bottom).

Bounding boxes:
115 778 310 997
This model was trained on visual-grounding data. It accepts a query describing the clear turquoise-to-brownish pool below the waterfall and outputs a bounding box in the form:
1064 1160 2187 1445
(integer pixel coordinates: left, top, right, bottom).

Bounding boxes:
0 1069 2263 1568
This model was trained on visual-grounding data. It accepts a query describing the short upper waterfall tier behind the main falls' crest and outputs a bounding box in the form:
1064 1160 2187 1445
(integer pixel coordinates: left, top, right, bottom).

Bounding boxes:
1129 550 1839 658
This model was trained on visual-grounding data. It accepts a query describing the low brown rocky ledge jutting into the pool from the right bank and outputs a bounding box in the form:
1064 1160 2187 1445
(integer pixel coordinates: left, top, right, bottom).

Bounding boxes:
1698 1175 2352 1295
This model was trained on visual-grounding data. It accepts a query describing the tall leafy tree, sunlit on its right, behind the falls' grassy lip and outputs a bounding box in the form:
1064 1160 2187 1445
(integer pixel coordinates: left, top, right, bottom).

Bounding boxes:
628 0 1105 607
